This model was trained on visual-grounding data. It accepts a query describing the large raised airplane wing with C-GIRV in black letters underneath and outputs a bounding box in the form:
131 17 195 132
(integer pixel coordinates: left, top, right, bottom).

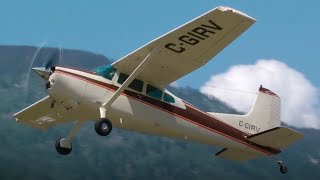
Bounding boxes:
112 7 255 87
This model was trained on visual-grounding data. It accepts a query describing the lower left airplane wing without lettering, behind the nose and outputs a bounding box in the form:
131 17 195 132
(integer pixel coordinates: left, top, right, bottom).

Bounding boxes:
14 96 91 129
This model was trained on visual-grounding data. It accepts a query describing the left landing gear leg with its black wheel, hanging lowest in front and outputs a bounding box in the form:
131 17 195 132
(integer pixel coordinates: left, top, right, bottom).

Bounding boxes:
56 121 84 155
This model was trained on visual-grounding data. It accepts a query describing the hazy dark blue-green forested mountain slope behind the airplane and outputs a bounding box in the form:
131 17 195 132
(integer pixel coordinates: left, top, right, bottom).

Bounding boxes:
0 46 320 179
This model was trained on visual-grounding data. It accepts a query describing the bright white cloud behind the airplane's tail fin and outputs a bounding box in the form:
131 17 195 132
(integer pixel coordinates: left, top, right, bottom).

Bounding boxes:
200 60 320 129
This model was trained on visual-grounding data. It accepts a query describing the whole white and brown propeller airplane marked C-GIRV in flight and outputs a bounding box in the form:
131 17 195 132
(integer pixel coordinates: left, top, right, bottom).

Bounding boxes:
14 7 303 173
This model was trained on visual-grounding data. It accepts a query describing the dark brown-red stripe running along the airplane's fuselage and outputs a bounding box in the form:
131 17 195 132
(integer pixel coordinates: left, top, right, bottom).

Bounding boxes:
55 68 281 155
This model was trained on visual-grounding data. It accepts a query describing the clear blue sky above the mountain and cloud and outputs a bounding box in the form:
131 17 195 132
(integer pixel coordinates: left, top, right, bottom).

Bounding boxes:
0 0 320 88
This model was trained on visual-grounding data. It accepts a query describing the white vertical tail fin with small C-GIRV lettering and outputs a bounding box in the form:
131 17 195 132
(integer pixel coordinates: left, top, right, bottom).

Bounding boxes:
209 86 281 134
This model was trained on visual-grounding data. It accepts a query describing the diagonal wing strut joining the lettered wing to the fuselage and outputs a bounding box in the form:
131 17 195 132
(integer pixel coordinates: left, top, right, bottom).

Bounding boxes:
100 50 155 118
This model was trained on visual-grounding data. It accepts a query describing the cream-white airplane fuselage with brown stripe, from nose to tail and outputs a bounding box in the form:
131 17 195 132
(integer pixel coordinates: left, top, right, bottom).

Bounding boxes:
48 67 278 155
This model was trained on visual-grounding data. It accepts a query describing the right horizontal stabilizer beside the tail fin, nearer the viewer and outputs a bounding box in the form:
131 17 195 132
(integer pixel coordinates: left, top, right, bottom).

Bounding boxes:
247 127 303 149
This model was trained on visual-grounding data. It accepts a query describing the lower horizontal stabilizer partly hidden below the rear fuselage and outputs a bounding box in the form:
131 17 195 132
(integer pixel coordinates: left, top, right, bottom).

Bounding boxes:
216 148 261 161
